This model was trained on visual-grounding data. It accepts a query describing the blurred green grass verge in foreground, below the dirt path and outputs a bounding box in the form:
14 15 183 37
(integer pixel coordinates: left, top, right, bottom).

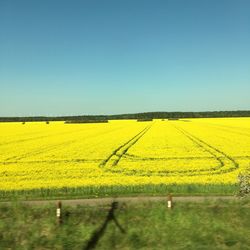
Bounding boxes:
0 200 250 250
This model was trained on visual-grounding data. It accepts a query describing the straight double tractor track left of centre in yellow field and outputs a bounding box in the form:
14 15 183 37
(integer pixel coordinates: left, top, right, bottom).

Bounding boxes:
99 125 152 167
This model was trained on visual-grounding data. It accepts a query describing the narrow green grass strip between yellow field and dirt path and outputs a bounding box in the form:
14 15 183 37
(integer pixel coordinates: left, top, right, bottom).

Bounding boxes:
0 184 239 201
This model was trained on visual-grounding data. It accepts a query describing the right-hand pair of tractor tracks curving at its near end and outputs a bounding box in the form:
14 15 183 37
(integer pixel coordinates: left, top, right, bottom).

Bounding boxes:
174 126 239 174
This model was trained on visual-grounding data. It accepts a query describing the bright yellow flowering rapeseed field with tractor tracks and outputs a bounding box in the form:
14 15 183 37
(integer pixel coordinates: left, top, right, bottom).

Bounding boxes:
0 118 250 195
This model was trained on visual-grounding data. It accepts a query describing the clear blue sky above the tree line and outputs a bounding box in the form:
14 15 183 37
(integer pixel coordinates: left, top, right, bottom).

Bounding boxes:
0 0 250 116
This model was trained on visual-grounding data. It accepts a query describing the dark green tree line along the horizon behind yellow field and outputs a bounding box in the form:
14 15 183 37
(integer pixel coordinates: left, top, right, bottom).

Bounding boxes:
0 110 250 122
